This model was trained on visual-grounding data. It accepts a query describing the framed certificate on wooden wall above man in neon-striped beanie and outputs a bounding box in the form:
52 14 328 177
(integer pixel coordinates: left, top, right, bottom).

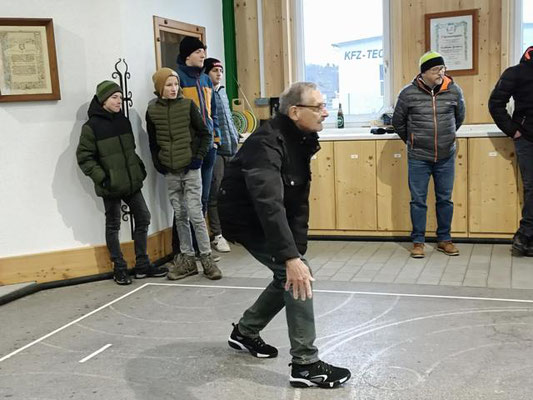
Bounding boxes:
425 9 478 75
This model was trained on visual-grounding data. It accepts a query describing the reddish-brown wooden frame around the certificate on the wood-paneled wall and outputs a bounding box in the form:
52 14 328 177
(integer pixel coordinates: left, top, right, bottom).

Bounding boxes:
424 9 479 76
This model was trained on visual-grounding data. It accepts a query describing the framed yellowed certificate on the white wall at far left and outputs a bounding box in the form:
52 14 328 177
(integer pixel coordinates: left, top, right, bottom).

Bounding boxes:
0 18 61 102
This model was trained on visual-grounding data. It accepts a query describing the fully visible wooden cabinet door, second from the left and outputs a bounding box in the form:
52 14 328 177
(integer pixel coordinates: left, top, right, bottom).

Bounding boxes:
334 140 377 231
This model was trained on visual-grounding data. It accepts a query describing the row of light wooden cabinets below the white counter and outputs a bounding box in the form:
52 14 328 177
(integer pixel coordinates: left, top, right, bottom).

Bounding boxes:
309 137 521 238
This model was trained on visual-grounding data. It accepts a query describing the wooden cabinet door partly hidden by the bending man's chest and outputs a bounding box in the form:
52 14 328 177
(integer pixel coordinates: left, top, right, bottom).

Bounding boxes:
309 142 335 229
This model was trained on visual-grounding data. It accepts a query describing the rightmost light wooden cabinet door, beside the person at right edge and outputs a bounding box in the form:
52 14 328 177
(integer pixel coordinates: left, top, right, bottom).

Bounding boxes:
468 137 518 236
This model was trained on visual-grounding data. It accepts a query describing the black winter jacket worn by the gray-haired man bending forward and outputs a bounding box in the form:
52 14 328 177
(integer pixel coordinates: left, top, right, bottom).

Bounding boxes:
218 115 320 262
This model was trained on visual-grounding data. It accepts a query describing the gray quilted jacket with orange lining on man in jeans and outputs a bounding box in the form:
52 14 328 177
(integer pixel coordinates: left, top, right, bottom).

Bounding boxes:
392 75 465 162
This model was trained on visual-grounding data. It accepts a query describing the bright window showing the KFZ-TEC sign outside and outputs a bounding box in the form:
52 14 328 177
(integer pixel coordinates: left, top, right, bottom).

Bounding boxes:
296 0 391 126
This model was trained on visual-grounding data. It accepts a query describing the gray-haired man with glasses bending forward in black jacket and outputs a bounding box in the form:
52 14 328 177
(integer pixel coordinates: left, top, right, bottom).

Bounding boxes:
218 82 350 388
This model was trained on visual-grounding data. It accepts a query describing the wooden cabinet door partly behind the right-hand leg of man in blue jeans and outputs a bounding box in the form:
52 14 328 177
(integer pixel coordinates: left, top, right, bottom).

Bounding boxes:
426 139 468 236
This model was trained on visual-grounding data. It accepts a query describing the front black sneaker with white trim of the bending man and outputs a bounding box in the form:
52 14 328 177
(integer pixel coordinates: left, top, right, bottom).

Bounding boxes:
289 361 352 388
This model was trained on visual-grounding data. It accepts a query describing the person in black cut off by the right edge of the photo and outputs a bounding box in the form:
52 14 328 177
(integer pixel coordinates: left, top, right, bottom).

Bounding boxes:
489 46 533 257
